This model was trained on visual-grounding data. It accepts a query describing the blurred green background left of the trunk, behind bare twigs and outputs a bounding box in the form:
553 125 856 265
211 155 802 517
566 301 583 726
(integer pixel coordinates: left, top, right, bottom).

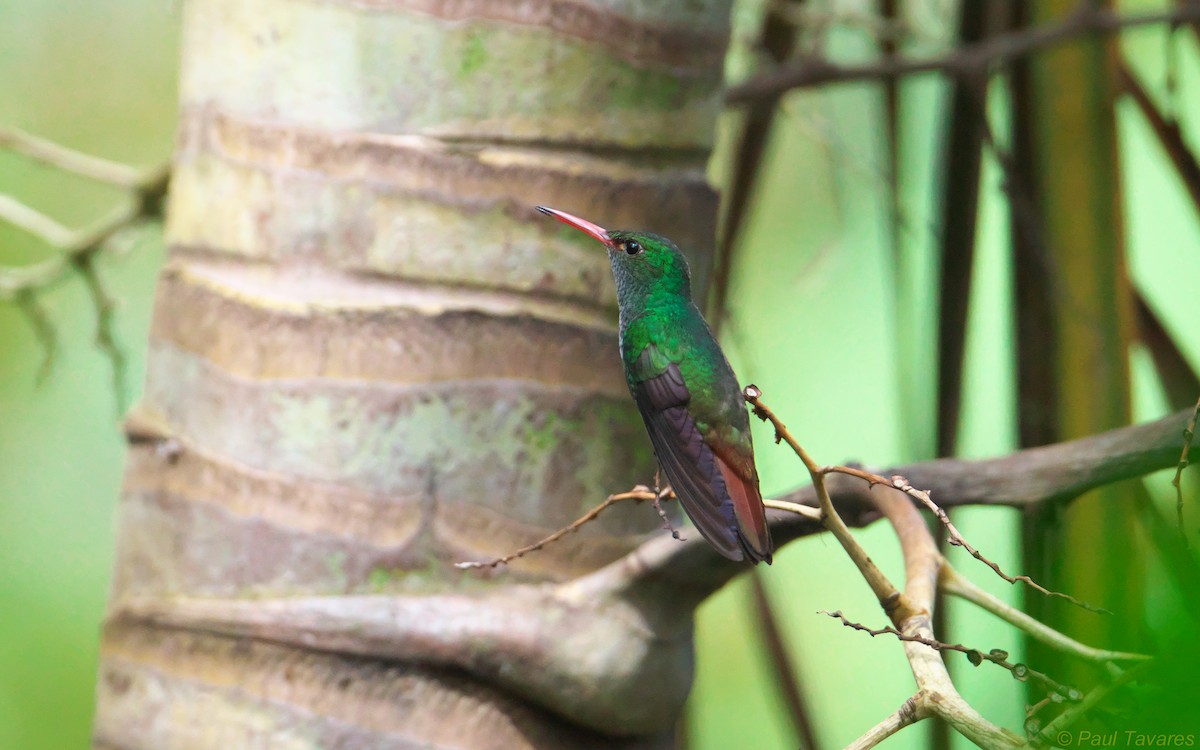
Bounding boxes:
0 0 179 750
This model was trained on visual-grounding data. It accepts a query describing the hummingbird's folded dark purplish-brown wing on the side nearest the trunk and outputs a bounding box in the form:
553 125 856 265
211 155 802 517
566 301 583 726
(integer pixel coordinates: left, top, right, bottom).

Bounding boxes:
629 344 744 560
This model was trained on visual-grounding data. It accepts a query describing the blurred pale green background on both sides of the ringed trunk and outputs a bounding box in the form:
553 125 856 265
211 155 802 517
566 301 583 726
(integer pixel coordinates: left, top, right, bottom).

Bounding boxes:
0 0 1200 750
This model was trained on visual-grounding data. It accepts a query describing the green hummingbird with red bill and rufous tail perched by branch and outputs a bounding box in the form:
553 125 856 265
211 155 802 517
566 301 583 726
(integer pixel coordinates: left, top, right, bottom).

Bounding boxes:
538 205 772 564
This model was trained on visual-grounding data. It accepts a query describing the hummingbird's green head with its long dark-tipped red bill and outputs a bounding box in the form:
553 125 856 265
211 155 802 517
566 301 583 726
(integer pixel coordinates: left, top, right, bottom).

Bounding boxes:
538 205 691 307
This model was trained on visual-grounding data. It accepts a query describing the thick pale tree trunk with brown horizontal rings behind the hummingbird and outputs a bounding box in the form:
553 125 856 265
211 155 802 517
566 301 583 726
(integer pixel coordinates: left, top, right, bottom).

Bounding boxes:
95 0 730 750
